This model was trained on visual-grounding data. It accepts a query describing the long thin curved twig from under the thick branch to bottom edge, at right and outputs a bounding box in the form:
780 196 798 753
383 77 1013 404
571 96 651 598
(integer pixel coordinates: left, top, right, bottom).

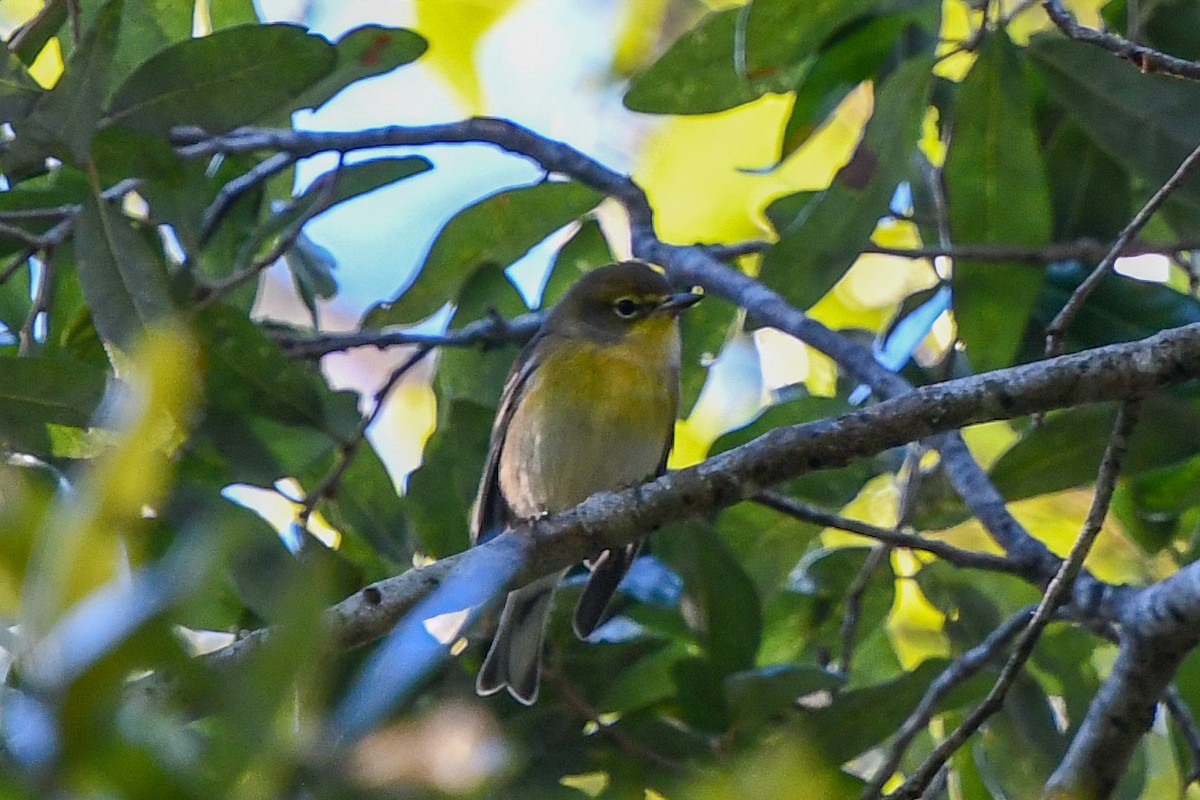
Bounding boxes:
888 399 1141 800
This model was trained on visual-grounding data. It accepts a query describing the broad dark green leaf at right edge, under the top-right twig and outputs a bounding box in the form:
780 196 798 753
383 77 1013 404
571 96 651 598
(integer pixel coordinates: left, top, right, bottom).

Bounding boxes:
1026 34 1200 211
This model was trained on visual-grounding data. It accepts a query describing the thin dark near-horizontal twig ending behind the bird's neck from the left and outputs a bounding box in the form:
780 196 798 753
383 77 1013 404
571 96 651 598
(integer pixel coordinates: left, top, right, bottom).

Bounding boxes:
271 313 541 359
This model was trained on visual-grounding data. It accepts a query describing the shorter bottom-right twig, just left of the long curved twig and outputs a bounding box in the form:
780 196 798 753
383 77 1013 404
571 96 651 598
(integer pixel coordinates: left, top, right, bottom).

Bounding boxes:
860 604 1036 800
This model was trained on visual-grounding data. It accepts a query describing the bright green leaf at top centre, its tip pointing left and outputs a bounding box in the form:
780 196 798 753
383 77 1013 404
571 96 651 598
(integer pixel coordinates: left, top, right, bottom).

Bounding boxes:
624 6 809 114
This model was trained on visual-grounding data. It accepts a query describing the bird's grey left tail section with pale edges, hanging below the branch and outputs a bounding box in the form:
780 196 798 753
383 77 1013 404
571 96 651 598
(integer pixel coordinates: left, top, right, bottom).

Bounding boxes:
475 573 562 705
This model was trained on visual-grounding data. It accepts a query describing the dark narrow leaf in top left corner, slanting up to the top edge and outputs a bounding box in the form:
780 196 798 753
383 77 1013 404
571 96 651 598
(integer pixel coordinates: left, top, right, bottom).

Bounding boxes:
5 0 122 175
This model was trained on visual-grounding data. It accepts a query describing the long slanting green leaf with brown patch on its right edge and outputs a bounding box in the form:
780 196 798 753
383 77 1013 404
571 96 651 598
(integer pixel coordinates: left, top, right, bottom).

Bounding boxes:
761 58 932 308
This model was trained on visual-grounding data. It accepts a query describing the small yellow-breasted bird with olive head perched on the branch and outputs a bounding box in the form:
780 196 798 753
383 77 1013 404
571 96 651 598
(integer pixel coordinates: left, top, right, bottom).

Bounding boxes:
470 261 701 705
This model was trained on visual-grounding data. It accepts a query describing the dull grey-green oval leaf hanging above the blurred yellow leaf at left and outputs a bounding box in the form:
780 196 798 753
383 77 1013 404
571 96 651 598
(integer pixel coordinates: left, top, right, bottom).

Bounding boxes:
74 192 174 349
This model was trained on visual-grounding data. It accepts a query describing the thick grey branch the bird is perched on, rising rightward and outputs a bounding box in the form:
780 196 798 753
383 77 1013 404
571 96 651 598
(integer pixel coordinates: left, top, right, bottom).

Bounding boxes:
210 324 1200 662
